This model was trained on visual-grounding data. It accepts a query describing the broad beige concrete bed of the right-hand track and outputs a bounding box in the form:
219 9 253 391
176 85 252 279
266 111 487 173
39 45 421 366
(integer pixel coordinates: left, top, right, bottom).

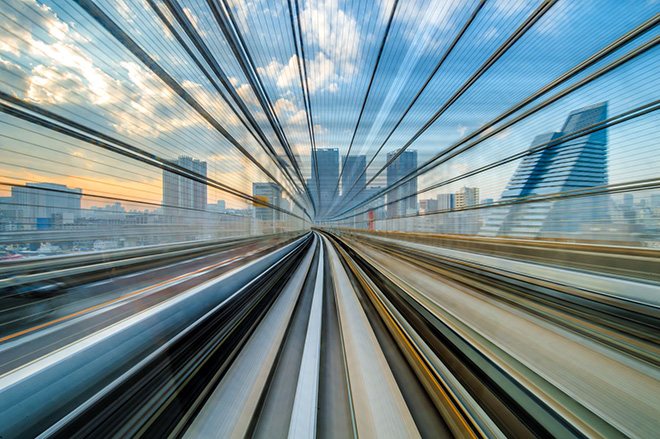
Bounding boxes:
340 232 660 438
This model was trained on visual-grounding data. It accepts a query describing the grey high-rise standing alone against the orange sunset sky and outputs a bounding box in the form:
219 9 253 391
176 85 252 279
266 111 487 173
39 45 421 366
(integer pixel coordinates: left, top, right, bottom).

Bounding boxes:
163 156 207 216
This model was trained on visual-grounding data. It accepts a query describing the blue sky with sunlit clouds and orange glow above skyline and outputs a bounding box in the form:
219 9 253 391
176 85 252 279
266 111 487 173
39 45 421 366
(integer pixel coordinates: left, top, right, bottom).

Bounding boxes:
0 0 660 220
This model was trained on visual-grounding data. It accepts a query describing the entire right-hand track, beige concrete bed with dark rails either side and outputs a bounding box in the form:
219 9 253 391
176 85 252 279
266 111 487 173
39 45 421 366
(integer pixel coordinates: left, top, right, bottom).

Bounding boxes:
324 230 658 437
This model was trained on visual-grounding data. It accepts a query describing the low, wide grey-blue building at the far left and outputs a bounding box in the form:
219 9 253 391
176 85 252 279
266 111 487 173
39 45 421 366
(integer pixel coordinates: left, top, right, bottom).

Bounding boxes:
11 183 82 224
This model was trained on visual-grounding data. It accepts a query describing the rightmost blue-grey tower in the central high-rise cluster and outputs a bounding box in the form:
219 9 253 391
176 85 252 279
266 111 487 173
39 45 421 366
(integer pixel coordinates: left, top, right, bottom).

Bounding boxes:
387 150 417 218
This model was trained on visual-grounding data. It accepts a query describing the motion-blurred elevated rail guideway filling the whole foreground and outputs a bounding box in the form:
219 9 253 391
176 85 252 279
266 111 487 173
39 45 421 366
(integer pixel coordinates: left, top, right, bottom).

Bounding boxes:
0 232 660 439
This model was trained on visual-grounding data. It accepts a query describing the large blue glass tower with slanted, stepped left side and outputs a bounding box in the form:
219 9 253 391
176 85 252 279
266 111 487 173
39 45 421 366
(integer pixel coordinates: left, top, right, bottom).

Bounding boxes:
479 103 609 236
